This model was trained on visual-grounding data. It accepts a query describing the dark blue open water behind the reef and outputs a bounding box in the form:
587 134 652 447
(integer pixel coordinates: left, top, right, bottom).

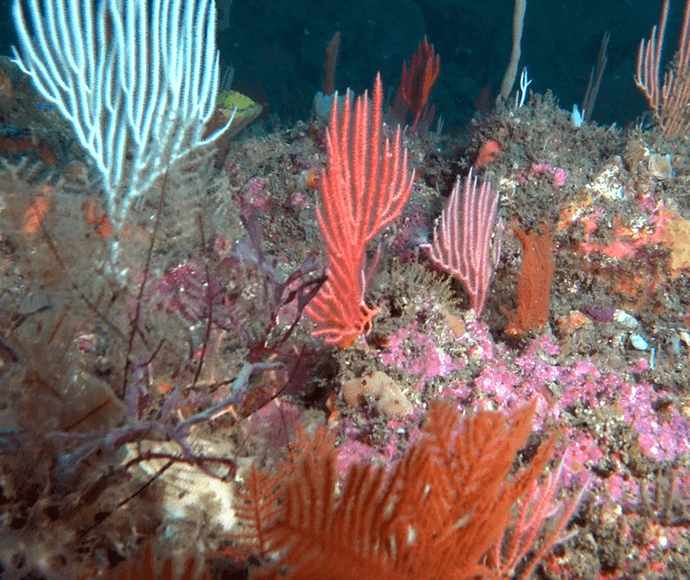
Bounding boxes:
0 0 684 133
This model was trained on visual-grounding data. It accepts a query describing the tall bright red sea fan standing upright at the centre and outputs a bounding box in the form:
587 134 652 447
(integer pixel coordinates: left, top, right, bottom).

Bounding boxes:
305 75 414 347
